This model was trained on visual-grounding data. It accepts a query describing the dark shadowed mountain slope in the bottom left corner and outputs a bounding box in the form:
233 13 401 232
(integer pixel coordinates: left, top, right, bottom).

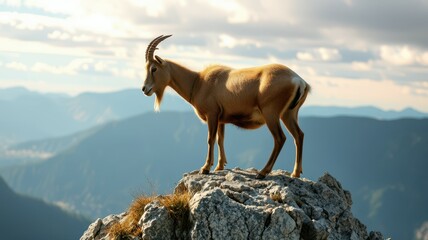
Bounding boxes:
0 174 89 240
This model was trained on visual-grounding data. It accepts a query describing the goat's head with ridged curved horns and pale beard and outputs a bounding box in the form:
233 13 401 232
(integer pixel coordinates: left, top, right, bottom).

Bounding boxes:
142 35 172 99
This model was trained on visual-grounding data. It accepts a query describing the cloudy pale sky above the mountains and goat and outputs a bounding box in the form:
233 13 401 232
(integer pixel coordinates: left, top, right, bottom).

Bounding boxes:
0 0 428 112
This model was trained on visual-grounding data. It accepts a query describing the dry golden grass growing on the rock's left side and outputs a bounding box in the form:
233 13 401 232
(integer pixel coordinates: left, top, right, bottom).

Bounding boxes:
109 192 191 240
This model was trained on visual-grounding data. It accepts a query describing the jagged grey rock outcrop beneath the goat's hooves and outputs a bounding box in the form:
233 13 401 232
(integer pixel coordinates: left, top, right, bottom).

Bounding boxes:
81 168 383 240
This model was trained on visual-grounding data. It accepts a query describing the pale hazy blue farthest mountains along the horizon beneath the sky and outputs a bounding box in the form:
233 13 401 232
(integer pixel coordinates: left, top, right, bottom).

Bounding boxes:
0 87 428 145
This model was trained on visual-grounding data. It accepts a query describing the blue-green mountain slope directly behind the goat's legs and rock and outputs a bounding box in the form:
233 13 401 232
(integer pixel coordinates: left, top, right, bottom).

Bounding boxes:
0 112 428 239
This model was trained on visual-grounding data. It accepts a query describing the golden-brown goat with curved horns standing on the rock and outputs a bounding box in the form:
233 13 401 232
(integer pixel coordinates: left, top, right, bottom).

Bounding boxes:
142 35 310 179
